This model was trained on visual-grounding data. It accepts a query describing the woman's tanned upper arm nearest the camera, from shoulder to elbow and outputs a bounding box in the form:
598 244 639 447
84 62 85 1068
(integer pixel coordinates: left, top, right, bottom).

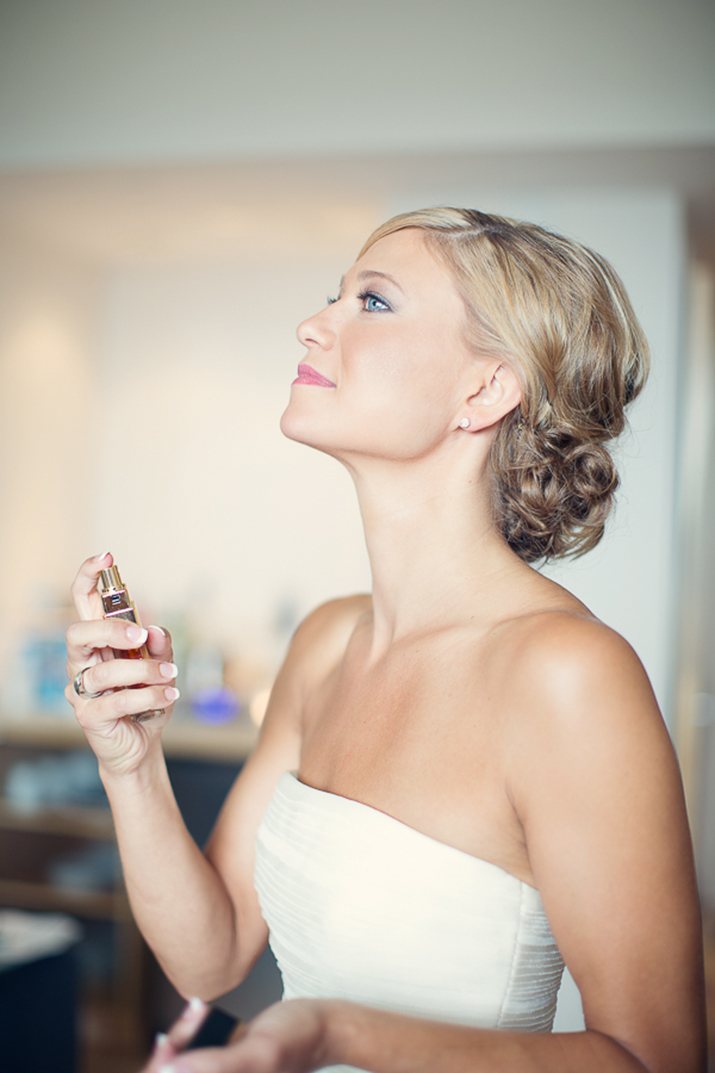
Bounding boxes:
510 617 704 1073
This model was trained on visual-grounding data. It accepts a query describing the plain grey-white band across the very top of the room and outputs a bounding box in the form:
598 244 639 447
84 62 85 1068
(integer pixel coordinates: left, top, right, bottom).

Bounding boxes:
0 0 715 167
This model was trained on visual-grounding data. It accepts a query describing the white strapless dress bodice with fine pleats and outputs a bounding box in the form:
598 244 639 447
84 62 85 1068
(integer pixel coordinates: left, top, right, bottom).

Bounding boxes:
256 771 564 1073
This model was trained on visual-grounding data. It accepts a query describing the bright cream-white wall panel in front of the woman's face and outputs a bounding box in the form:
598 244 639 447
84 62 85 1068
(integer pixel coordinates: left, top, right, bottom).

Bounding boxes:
87 249 369 652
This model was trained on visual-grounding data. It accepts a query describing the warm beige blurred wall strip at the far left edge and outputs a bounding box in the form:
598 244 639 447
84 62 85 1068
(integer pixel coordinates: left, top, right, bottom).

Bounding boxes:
0 242 98 648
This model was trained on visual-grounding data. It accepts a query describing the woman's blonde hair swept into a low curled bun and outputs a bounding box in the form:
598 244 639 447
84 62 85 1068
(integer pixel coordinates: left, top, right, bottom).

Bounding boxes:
360 208 648 562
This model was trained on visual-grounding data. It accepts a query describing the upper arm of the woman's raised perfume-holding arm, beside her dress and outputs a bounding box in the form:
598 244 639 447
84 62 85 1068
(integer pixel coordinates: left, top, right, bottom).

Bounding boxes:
201 598 362 971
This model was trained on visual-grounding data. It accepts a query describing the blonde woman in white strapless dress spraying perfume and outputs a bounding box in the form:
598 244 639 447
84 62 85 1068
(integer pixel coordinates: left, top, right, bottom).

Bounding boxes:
68 209 704 1073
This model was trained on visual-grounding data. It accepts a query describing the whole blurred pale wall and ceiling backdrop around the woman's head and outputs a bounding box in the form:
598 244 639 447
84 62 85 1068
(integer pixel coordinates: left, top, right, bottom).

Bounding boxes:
0 0 715 1055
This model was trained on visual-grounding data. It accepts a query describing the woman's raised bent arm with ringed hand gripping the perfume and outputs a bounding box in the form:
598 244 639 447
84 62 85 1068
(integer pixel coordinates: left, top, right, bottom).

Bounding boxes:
67 556 302 998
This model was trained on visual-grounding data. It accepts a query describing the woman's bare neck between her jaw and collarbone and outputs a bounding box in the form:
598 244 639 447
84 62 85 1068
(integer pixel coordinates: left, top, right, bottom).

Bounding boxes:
346 439 530 653
